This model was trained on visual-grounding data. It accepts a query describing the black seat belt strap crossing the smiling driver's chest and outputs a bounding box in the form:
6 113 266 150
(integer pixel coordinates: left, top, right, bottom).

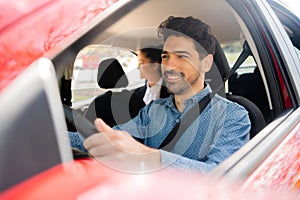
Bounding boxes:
159 92 215 152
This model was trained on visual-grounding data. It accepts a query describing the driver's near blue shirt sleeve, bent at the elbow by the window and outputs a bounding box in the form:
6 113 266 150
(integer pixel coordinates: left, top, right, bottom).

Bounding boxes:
160 106 251 173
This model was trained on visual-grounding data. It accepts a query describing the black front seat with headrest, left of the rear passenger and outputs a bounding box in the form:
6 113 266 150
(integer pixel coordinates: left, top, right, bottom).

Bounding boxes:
84 58 132 126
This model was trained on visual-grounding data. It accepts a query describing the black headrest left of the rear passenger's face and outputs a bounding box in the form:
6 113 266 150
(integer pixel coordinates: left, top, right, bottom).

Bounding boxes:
97 58 128 89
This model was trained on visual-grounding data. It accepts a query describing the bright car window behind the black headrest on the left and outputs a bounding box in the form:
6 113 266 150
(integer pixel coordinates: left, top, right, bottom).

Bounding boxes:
71 45 144 111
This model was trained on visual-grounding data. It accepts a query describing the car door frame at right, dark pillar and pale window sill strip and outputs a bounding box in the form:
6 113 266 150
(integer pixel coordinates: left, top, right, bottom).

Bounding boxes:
211 0 300 180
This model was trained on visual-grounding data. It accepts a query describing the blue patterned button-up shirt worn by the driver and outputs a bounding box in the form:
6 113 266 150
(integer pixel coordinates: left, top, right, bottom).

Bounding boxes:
69 86 251 173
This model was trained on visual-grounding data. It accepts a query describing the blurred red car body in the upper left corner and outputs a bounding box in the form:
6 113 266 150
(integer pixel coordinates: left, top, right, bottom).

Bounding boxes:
0 0 118 91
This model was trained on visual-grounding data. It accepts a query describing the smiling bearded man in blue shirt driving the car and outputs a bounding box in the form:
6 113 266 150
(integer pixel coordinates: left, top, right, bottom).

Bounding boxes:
69 17 250 173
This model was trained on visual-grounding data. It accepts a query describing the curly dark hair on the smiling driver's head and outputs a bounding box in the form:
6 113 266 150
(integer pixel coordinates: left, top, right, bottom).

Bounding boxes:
158 16 215 59
